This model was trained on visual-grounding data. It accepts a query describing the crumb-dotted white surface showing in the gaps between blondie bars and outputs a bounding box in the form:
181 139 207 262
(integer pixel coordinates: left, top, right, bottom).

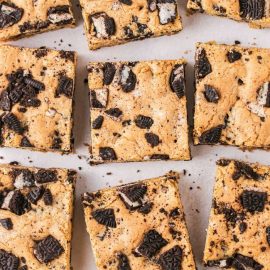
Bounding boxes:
0 0 270 270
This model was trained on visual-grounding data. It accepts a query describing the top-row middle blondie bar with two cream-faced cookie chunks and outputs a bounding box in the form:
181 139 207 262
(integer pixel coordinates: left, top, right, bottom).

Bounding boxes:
80 0 182 50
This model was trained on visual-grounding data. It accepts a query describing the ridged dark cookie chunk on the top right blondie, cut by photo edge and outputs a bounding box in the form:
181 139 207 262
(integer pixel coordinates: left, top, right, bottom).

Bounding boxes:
239 0 265 20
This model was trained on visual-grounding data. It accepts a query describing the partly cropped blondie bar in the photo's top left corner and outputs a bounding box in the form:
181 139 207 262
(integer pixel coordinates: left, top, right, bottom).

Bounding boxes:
0 0 75 41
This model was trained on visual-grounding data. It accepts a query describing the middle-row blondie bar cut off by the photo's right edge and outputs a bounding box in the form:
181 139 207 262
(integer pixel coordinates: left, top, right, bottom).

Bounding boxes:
194 43 270 149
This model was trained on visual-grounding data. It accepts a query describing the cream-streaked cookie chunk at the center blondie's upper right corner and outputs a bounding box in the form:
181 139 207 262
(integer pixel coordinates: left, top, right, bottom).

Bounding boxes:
170 64 185 99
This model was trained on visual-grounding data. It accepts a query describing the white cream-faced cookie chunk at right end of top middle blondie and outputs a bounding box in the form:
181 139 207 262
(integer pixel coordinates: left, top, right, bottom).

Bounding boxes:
157 0 177 25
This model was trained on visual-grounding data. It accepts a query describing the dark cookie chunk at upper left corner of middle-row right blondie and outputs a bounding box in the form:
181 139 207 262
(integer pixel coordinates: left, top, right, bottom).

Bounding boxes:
195 49 212 80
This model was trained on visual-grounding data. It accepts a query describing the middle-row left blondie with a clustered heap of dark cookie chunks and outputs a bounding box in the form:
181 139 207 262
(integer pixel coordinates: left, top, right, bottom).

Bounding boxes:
0 46 76 153
